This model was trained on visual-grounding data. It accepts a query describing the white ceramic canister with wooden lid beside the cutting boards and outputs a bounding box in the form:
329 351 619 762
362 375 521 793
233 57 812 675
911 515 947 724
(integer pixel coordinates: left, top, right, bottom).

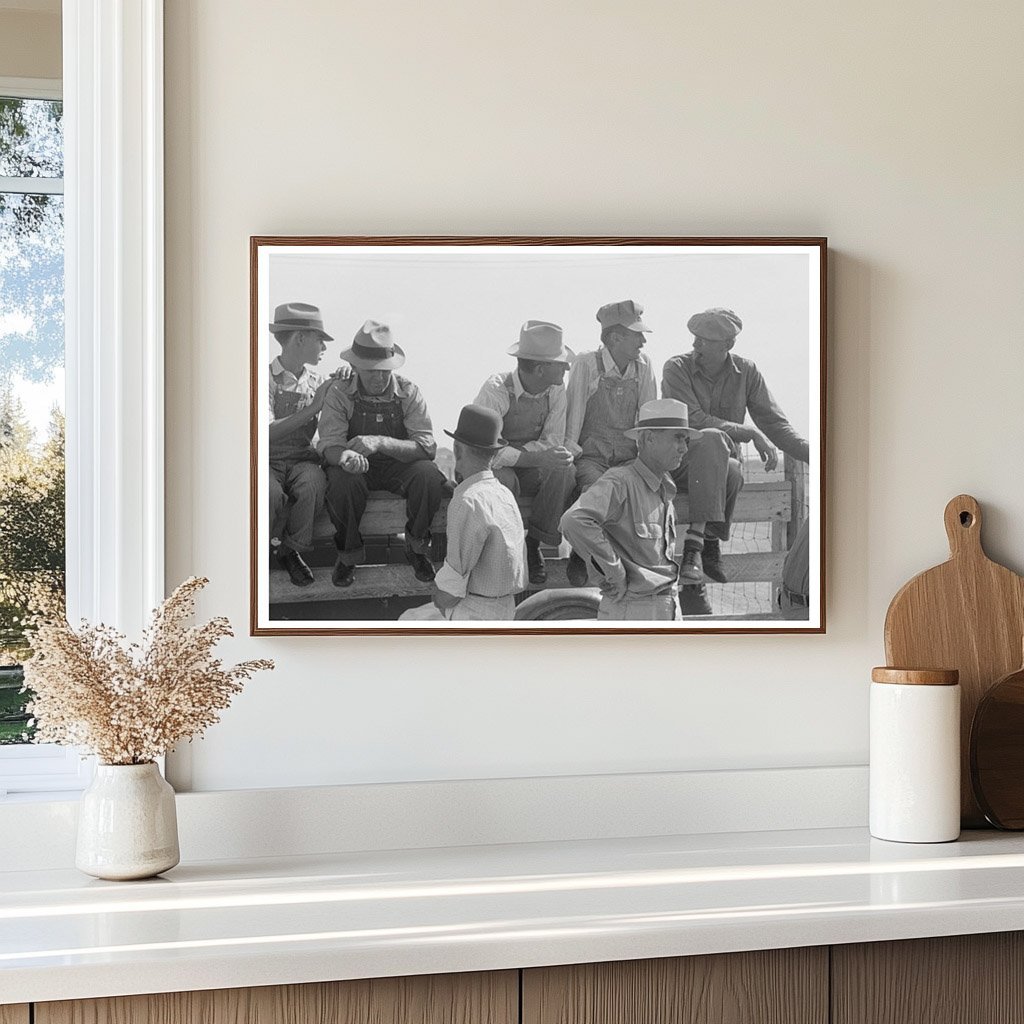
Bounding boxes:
869 669 961 843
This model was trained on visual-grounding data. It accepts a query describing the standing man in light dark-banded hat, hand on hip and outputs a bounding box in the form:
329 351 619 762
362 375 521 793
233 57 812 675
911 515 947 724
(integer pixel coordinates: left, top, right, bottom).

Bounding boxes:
561 398 699 622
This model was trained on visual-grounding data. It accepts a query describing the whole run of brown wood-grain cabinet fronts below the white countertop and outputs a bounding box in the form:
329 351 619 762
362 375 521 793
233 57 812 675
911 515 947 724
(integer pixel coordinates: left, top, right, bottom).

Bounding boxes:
16 932 1024 1024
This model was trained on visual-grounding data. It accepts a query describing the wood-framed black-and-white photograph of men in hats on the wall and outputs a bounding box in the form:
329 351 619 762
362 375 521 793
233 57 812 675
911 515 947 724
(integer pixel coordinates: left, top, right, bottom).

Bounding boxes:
250 237 827 636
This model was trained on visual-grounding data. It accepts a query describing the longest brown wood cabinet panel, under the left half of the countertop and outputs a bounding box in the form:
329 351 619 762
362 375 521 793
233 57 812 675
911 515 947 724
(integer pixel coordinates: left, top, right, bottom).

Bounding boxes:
36 971 519 1024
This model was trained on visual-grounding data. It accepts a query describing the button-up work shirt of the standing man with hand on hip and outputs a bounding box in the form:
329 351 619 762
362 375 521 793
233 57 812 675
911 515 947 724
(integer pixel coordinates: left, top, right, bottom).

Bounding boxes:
560 459 679 597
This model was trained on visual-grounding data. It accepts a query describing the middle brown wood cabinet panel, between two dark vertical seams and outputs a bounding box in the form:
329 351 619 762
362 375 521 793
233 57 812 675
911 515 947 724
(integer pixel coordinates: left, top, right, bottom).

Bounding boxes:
522 948 828 1024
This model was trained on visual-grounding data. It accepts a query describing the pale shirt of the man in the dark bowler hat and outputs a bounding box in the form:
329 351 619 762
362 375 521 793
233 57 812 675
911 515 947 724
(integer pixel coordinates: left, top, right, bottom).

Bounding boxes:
434 469 526 597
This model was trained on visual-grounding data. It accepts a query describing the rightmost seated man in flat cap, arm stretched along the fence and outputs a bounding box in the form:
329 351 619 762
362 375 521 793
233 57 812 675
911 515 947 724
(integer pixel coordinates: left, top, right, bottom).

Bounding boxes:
662 307 809 613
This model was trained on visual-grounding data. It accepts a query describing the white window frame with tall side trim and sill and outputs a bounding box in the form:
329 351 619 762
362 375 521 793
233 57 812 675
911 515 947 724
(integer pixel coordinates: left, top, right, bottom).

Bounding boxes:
0 0 164 799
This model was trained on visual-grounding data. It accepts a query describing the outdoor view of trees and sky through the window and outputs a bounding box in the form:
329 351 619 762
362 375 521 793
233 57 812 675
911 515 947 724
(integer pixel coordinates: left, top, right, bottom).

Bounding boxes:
0 95 65 744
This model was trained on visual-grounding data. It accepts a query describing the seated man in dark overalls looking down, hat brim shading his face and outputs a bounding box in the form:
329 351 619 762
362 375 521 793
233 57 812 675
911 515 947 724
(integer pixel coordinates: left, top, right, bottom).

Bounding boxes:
318 319 445 587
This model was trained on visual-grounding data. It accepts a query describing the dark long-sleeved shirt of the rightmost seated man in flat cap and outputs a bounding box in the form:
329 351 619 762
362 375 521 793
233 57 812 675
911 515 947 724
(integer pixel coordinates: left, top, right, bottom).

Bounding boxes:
662 352 809 462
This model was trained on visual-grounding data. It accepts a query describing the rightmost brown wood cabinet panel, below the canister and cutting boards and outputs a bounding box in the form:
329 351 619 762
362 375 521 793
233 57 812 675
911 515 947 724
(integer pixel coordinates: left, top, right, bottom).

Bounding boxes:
831 932 1024 1024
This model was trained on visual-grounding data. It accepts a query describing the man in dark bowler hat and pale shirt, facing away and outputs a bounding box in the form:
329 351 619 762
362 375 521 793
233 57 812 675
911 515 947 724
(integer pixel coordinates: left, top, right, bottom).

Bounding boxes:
434 404 526 622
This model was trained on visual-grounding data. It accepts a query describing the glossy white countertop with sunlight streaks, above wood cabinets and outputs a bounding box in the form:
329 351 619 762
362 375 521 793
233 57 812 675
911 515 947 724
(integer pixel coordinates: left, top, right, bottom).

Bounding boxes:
0 828 1024 1002
